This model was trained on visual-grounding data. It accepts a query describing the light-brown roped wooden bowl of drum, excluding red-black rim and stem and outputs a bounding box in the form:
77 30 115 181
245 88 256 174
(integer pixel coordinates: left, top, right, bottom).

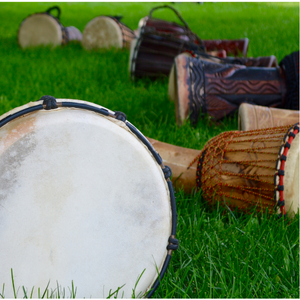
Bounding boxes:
197 126 289 212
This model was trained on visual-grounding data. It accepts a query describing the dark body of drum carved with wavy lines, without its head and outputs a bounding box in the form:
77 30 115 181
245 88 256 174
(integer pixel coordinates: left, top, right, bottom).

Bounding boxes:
187 57 286 124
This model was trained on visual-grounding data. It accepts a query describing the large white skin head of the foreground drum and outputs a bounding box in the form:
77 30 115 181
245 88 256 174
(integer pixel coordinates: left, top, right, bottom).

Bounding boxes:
0 99 172 298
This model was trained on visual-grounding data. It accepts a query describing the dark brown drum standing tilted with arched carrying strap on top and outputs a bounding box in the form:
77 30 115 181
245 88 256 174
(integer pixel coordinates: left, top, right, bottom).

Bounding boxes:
129 5 205 79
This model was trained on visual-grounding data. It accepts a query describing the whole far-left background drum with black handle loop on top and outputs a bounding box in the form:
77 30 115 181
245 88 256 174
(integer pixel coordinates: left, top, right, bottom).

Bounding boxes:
18 6 82 48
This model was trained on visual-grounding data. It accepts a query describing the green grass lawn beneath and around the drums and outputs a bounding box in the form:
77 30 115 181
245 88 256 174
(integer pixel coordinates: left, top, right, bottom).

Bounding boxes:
0 2 299 298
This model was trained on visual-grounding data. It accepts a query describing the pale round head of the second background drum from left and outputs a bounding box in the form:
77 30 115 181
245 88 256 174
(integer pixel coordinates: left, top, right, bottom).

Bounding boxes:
82 16 123 50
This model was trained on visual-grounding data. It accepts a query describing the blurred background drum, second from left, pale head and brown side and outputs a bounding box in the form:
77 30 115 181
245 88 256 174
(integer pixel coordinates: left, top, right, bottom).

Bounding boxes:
82 16 135 50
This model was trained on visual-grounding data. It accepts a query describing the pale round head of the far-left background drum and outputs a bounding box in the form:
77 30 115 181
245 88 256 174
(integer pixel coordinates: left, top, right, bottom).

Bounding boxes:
18 14 62 48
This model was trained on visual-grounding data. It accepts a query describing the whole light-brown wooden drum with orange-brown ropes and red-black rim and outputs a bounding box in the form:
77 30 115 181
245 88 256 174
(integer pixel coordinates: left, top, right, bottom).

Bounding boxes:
149 123 299 215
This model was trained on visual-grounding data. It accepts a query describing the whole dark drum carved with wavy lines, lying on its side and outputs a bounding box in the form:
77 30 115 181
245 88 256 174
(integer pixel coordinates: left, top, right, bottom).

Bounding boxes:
169 52 299 125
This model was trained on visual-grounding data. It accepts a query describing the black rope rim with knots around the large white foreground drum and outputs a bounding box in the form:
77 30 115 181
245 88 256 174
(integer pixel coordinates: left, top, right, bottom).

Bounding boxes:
0 96 179 298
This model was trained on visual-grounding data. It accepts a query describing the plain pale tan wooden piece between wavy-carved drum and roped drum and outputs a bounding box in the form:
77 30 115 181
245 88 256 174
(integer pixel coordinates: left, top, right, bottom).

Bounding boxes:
238 103 299 131
